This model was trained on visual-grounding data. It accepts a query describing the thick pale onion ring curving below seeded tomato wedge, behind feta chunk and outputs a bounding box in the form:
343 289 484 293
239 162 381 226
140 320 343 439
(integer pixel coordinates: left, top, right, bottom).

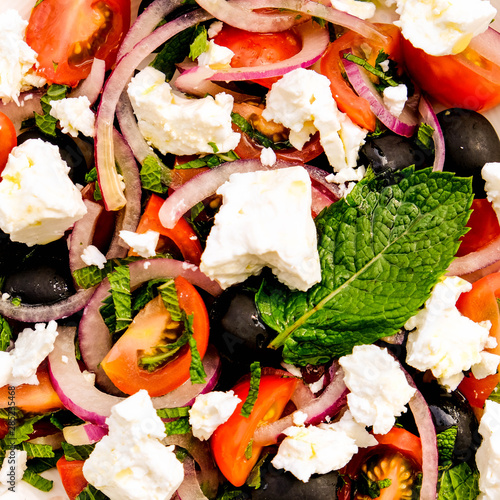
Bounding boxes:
49 327 220 426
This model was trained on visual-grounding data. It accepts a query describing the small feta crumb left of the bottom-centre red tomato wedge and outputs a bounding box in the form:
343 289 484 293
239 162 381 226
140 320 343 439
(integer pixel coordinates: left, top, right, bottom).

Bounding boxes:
189 391 241 441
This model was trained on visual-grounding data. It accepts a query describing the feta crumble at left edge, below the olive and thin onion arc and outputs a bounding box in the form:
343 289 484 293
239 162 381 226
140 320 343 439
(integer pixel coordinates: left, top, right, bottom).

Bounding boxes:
0 321 58 386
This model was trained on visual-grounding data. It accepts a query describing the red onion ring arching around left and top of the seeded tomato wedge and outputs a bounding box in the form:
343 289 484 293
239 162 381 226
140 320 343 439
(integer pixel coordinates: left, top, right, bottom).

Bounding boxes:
78 259 222 394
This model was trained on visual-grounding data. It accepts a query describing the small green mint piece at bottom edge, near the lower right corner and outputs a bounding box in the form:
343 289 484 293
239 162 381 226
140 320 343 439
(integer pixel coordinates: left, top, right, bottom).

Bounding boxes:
437 462 479 500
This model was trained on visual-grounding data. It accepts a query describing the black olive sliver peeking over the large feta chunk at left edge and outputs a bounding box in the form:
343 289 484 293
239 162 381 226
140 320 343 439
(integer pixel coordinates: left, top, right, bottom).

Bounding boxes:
17 129 87 185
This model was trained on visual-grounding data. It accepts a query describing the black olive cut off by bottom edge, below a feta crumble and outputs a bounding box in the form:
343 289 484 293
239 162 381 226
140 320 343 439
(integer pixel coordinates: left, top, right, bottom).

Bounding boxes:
251 463 338 500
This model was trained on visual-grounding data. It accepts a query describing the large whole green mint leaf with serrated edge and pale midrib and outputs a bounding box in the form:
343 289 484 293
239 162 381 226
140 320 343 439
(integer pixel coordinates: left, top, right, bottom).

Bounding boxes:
257 168 472 365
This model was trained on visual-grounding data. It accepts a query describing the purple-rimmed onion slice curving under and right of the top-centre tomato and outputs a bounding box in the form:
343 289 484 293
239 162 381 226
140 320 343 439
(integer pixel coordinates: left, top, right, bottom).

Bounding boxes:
176 21 330 89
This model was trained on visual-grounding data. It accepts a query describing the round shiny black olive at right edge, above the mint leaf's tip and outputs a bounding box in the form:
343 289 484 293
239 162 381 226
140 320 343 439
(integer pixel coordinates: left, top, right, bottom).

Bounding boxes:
437 108 500 198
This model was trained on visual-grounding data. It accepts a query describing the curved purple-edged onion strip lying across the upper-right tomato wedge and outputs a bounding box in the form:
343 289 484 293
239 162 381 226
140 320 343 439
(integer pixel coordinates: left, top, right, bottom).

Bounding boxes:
343 50 418 137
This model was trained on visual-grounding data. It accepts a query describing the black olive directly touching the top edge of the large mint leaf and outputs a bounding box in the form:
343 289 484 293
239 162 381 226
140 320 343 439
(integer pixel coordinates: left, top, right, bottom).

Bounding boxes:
358 134 434 173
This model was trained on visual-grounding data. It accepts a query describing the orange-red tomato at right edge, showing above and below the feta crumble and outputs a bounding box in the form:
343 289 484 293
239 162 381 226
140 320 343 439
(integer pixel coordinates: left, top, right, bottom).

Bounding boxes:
457 273 500 408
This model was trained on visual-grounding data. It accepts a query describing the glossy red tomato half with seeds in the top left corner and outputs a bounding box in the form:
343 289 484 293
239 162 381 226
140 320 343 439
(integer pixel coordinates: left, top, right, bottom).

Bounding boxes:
26 0 131 86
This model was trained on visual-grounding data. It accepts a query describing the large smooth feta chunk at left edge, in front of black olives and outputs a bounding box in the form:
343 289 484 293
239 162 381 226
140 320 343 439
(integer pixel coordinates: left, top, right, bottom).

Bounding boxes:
0 139 87 246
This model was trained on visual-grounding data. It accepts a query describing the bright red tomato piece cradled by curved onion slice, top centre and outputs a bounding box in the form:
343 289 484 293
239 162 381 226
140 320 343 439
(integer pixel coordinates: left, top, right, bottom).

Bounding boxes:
213 24 302 89
